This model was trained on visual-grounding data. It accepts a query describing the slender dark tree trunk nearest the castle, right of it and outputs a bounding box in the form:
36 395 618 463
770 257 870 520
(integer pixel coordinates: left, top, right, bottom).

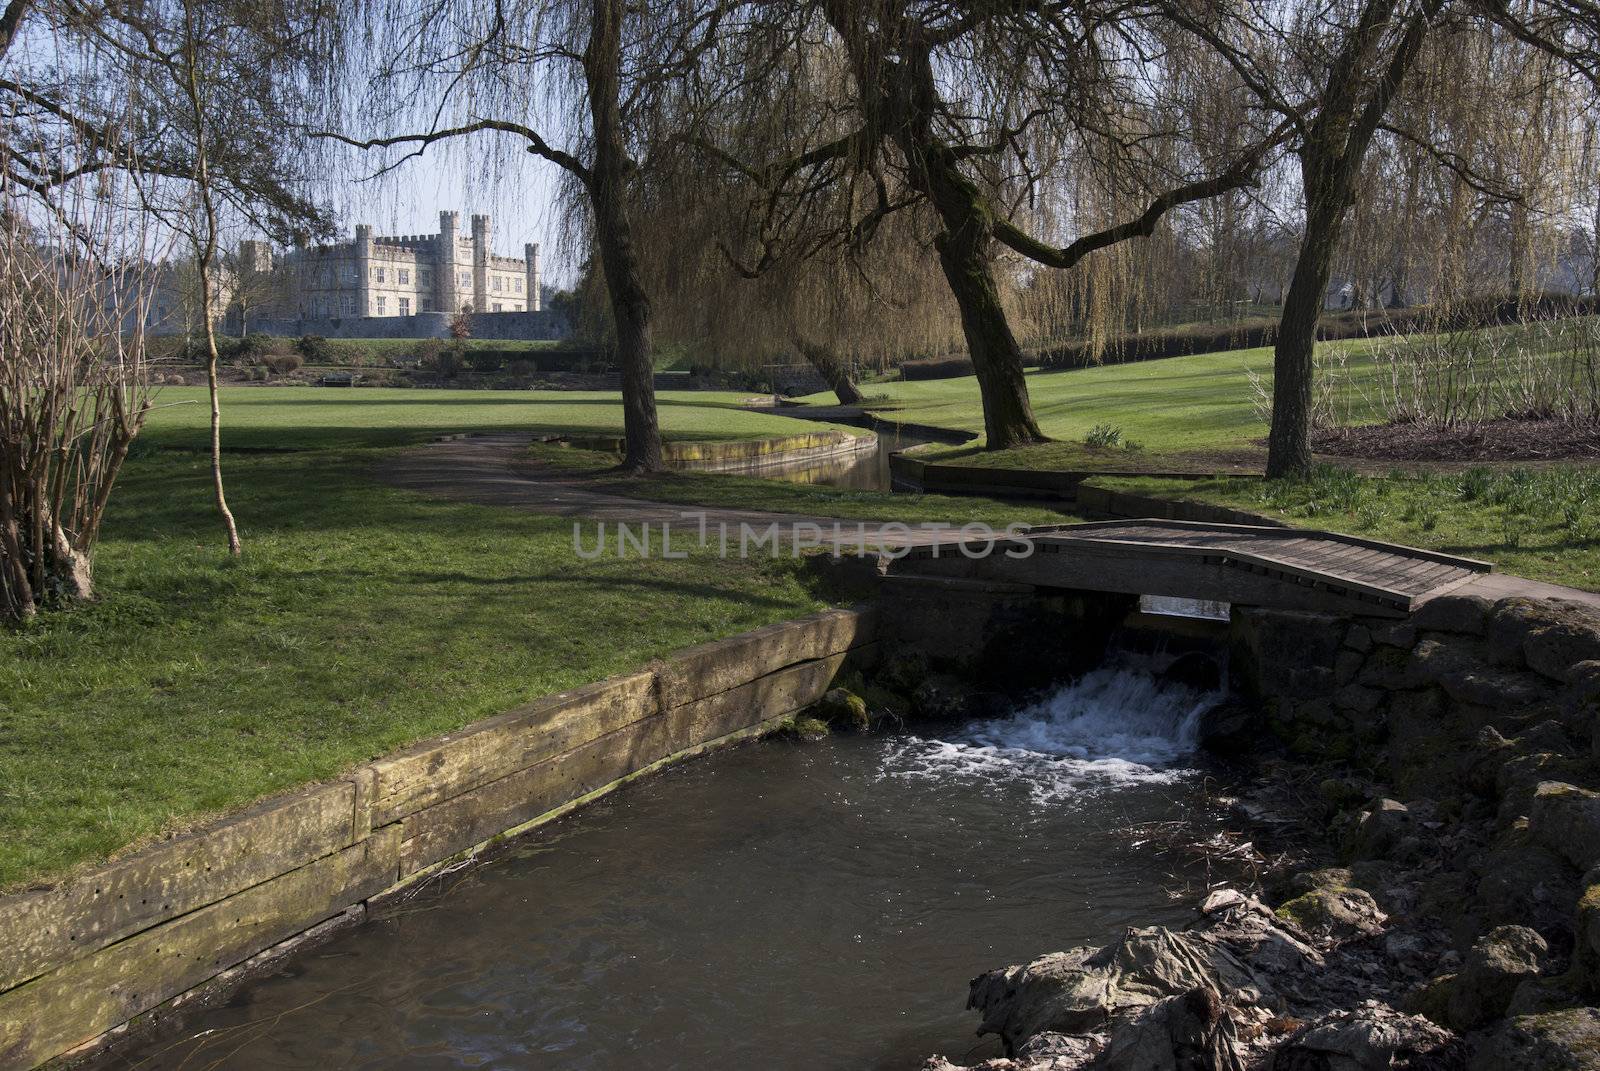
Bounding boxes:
584 0 664 472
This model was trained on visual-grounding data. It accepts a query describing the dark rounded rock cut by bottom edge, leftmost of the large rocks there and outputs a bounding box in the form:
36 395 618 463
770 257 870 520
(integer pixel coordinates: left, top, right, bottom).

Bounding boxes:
1091 986 1245 1071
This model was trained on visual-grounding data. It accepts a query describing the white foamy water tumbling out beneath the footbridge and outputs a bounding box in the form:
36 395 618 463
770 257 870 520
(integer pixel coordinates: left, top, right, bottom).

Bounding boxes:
883 669 1221 802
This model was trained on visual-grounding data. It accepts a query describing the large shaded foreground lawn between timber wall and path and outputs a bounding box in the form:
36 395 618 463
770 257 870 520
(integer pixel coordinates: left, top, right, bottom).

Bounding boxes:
0 450 819 885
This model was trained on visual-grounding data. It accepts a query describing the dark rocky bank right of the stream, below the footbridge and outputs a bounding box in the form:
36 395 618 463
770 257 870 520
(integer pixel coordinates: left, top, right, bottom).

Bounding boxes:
926 596 1600 1071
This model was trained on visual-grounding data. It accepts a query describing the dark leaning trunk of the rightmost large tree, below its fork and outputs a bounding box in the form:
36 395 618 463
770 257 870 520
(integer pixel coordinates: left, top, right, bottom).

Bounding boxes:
1267 174 1349 479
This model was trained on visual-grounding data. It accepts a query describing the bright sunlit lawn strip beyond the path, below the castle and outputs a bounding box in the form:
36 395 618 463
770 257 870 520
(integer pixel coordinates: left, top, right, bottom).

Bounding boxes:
139 387 848 450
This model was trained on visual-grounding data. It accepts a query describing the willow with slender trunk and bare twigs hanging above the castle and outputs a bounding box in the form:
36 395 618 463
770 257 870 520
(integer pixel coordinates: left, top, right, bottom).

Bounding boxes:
322 0 722 472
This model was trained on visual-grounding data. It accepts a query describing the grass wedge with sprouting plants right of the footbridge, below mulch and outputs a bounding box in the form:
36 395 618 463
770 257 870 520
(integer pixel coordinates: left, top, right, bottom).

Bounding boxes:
1094 466 1600 591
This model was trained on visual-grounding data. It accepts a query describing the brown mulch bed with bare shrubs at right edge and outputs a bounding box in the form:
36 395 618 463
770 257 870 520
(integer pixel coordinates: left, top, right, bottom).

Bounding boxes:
1312 419 1600 461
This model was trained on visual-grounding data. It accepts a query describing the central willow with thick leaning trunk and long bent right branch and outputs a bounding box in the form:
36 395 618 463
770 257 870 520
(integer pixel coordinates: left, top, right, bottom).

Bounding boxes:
681 0 1274 450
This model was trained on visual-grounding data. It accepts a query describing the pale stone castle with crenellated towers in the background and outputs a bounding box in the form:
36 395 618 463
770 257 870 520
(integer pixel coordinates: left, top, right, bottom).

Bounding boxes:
229 211 565 338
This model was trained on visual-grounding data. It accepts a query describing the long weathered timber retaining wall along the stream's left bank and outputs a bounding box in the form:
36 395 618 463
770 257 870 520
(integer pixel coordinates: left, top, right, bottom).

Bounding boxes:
0 610 877 1071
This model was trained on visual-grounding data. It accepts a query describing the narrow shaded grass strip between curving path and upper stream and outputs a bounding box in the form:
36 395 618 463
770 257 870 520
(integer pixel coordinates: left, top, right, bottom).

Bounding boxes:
531 445 1080 530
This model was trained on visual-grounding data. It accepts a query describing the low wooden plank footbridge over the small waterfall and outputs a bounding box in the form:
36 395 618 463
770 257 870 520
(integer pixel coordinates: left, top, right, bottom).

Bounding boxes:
890 520 1493 616
